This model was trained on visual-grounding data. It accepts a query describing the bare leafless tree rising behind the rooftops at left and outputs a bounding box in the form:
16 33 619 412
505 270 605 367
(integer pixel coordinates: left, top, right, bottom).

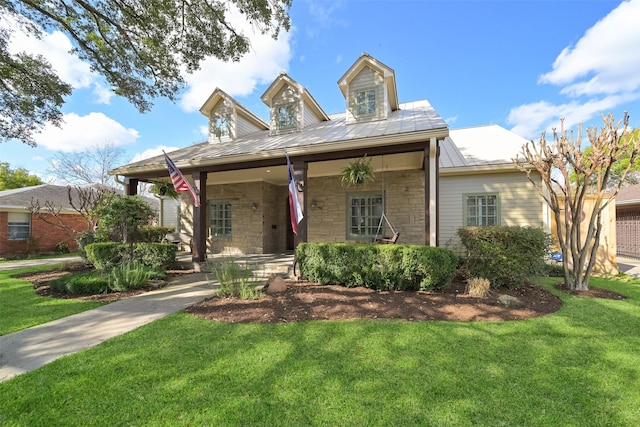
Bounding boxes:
49 144 124 186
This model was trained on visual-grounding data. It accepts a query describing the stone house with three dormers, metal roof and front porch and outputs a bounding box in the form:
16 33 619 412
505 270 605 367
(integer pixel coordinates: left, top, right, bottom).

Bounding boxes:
110 53 550 261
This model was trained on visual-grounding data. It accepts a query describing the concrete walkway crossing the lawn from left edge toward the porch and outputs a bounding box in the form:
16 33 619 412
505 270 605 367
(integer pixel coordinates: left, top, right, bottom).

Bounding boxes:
0 273 215 382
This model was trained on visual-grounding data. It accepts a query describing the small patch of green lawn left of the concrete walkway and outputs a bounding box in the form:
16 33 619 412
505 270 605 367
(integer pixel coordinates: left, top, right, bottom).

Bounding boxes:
0 265 103 335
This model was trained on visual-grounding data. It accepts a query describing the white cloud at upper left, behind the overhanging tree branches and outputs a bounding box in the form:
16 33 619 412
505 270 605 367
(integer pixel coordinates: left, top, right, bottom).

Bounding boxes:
0 16 113 104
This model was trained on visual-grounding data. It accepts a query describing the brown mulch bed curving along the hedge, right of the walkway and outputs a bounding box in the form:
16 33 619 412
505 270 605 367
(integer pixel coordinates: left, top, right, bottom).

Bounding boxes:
187 281 562 323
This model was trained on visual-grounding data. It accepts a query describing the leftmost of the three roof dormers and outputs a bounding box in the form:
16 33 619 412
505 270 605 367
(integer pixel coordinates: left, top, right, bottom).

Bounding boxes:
200 88 269 142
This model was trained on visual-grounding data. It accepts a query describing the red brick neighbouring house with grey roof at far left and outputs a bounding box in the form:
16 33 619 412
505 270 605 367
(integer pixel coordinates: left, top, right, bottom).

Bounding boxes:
0 184 158 257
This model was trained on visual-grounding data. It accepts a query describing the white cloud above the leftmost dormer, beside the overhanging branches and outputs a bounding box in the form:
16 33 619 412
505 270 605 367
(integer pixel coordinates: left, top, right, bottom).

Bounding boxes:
180 6 292 112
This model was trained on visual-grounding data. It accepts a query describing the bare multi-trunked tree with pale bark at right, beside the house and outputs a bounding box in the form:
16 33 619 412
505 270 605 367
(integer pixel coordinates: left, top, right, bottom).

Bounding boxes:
513 112 640 290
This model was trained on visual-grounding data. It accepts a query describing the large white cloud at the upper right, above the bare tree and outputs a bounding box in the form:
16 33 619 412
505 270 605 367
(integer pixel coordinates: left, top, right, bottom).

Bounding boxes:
507 0 640 138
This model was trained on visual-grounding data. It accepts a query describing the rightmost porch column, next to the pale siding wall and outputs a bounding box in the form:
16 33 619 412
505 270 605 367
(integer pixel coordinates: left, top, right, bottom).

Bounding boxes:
424 137 438 246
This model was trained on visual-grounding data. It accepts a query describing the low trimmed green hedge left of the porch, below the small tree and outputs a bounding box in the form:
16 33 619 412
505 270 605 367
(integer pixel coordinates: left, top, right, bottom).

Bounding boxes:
85 242 177 270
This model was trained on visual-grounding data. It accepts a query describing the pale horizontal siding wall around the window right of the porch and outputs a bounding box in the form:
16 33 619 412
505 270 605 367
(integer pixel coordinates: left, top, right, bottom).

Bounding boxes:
439 172 546 246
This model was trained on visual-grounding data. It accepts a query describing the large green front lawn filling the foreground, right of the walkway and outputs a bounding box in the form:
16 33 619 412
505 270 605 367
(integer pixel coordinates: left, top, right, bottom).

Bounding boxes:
0 279 640 426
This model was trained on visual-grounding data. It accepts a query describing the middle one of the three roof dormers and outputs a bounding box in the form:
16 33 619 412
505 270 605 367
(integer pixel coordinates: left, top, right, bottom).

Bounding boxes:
261 73 329 135
